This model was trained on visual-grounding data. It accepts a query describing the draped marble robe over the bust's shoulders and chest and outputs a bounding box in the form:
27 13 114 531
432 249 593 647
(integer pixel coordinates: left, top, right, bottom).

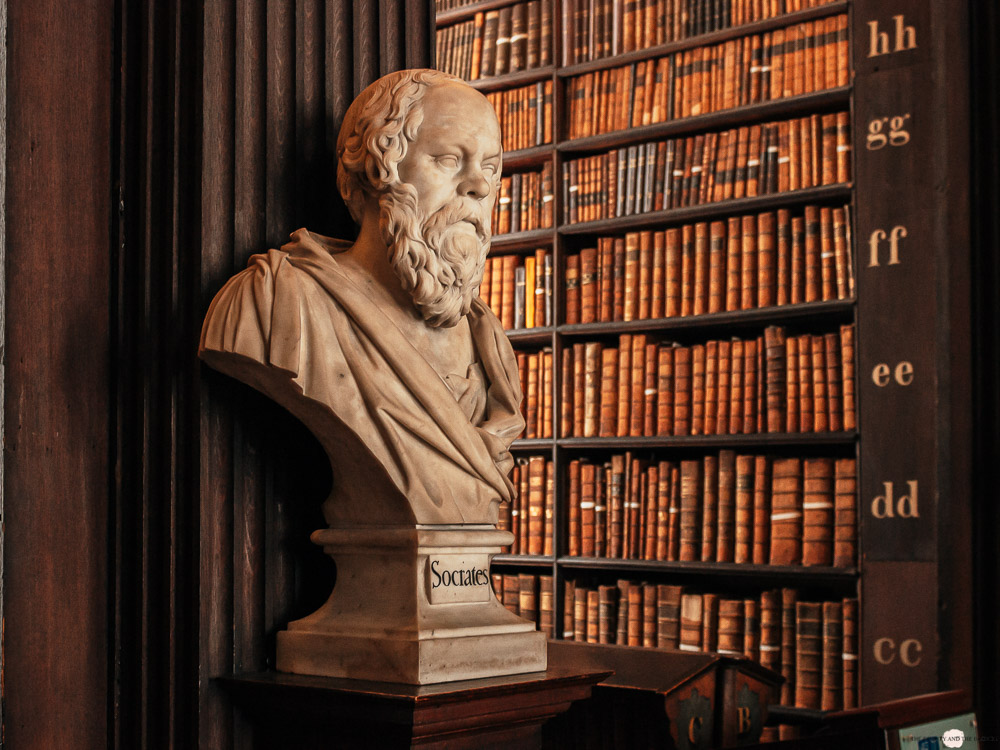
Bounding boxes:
199 229 524 526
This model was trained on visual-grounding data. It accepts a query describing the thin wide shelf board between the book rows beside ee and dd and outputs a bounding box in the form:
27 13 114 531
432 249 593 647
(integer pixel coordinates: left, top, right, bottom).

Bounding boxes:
556 431 858 451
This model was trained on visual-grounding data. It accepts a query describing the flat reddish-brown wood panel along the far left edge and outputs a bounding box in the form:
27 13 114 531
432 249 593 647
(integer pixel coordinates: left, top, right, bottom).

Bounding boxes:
2 0 115 750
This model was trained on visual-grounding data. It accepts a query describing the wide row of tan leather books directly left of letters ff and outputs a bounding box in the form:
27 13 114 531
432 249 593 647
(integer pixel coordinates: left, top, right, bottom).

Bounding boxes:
564 206 854 324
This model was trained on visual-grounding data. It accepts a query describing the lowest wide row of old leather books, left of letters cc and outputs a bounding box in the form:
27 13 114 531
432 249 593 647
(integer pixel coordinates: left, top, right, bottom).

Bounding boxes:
568 580 858 711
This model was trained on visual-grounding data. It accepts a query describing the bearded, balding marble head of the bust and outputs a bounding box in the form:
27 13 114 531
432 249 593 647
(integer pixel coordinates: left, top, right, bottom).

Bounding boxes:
337 70 502 327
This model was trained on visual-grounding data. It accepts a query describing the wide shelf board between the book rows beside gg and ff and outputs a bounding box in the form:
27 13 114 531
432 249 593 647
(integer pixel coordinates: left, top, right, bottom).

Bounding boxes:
557 183 851 235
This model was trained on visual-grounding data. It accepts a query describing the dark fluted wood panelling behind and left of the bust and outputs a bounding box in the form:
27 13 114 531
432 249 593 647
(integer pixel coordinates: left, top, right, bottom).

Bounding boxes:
112 0 431 750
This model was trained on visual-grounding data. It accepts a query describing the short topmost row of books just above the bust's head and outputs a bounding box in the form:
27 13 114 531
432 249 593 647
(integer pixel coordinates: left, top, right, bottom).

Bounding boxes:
436 0 552 81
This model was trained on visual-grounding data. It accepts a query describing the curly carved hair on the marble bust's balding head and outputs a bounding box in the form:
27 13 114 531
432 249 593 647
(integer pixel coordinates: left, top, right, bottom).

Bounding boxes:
337 69 462 224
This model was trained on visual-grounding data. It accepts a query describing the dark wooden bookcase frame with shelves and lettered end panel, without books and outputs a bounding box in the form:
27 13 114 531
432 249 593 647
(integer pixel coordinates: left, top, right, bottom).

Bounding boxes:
437 0 972 703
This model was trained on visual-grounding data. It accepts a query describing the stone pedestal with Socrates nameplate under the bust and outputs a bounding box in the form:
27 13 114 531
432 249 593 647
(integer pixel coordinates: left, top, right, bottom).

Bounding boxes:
277 525 546 685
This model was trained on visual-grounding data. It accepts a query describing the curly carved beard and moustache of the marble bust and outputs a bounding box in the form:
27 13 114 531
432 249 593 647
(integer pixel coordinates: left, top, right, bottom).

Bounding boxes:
379 183 490 328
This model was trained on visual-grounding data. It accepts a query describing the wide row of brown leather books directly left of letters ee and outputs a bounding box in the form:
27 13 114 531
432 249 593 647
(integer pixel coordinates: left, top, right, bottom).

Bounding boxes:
559 325 857 437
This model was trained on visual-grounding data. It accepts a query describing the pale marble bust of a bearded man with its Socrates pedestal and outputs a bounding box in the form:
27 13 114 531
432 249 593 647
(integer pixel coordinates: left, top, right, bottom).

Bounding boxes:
199 70 545 683
